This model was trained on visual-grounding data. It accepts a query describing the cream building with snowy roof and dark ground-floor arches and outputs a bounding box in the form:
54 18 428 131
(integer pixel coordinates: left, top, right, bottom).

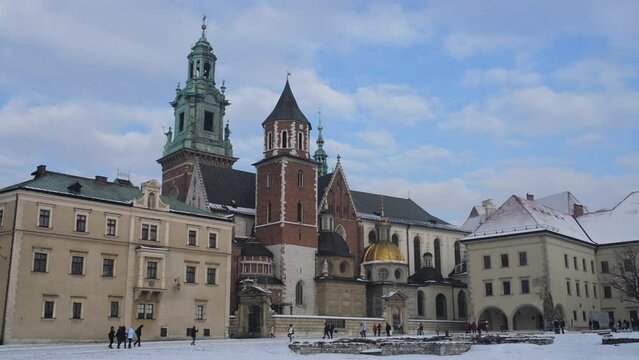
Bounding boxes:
462 193 639 330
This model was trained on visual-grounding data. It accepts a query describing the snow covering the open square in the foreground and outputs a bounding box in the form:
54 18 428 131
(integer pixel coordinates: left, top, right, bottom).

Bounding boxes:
0 332 639 360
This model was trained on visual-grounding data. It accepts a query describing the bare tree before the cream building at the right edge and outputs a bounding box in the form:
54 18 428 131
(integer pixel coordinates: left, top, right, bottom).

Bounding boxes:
606 246 639 304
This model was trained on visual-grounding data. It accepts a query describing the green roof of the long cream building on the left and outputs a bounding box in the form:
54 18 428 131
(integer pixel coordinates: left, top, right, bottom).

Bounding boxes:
0 171 222 219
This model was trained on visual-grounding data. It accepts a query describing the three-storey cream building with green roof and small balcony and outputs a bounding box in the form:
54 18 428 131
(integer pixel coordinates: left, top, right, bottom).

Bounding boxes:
0 166 233 343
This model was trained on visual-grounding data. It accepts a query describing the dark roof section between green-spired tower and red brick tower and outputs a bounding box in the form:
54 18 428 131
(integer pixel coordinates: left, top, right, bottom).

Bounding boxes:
200 164 255 209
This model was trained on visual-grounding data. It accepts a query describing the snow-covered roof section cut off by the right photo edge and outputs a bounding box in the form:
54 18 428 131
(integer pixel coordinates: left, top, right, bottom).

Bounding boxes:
577 191 639 244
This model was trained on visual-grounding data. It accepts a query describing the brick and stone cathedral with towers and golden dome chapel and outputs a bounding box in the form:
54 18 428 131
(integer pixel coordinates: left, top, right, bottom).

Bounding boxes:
158 25 468 336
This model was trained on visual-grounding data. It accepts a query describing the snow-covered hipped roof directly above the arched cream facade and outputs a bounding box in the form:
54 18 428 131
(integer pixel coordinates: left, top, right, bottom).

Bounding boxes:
464 195 592 243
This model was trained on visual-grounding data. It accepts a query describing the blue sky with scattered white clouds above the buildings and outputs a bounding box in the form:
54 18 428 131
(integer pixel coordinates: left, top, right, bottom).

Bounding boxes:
0 0 639 224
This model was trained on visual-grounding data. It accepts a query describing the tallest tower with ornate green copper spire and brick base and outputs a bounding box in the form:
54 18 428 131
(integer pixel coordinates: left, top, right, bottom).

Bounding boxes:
158 24 237 201
